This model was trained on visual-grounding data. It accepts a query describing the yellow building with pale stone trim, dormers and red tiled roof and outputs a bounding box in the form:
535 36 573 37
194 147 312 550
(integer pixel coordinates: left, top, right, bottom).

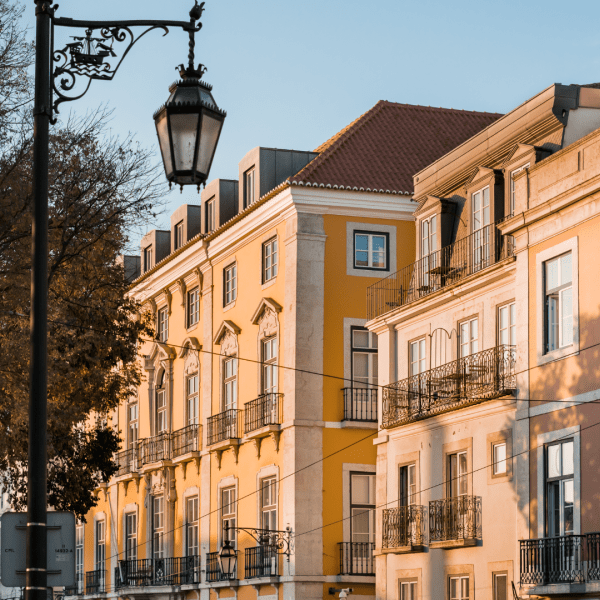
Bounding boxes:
67 103 496 600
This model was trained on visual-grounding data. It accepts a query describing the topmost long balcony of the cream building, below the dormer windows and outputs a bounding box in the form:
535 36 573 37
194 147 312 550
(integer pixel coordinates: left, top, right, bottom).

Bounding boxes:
367 224 515 320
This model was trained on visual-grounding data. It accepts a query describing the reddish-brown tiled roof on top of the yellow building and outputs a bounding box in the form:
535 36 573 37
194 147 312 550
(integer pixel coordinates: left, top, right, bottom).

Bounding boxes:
289 100 502 194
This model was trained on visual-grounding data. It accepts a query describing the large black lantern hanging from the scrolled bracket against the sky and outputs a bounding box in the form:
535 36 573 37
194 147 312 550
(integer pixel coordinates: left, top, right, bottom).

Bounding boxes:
154 2 226 191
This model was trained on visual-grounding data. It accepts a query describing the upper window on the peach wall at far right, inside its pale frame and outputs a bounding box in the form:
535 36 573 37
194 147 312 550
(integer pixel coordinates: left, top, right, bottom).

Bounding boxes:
544 252 573 352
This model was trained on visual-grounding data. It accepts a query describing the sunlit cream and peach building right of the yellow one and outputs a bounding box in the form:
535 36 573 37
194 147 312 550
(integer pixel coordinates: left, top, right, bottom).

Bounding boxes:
367 84 600 600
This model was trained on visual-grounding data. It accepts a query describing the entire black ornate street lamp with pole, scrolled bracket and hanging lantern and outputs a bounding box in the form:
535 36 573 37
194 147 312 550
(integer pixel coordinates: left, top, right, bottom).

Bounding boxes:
25 0 225 600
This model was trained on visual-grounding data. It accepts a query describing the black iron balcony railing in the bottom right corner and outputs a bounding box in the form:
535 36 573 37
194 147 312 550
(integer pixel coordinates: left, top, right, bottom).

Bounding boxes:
520 533 600 585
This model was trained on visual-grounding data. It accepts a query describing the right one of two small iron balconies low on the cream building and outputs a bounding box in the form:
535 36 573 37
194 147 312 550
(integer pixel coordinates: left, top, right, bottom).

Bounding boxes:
429 496 481 548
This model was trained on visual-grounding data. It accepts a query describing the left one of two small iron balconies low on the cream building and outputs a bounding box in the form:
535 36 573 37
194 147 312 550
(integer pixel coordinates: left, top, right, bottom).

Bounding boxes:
381 505 427 554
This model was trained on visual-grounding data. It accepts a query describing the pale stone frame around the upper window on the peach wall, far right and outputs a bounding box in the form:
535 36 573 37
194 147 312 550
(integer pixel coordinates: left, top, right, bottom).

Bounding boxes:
535 236 579 365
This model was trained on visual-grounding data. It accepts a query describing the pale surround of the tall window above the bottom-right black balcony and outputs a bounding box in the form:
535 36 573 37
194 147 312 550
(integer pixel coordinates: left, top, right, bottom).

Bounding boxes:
537 425 581 538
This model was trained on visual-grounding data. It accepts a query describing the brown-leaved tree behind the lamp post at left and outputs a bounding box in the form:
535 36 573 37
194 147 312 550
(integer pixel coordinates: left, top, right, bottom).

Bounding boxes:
0 0 163 517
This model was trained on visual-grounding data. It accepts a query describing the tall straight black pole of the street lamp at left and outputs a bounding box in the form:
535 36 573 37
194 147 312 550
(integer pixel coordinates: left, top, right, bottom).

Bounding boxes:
25 0 52 600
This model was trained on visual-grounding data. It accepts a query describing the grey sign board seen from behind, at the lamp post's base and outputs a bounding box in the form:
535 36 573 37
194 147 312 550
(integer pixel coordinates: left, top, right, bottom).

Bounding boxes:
0 512 75 587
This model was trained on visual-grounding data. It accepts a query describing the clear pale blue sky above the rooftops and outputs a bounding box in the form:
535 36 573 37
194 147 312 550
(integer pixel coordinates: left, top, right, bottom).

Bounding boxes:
36 0 600 242
